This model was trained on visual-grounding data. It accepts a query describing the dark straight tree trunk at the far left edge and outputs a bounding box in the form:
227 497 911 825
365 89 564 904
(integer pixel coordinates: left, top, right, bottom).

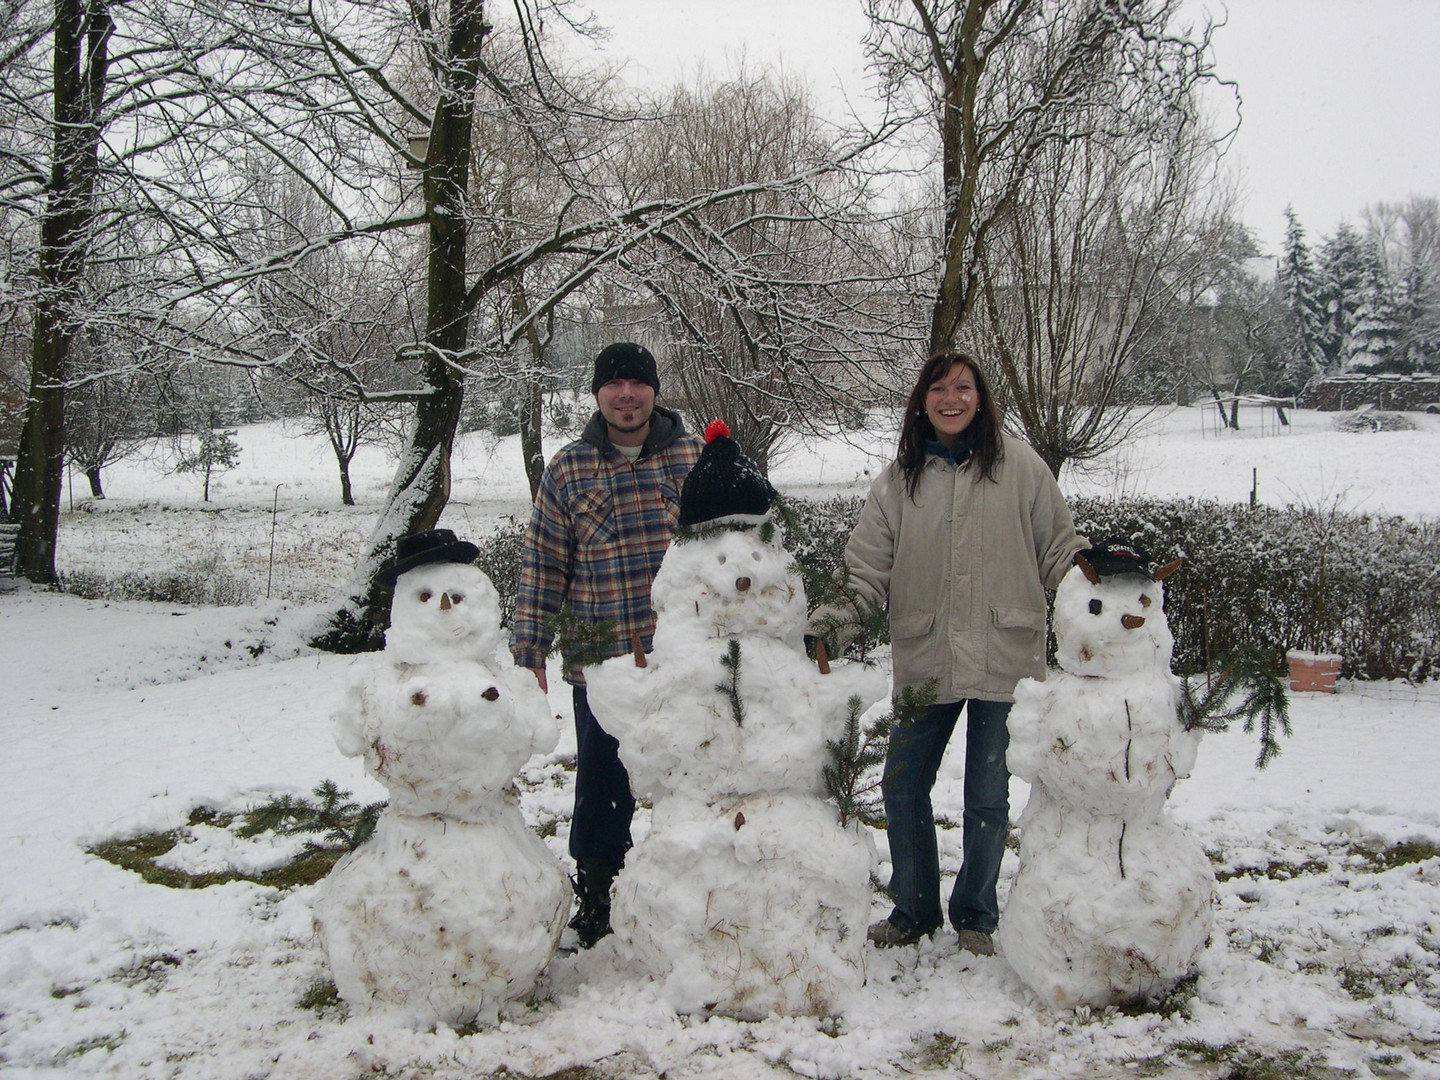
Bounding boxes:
12 0 112 585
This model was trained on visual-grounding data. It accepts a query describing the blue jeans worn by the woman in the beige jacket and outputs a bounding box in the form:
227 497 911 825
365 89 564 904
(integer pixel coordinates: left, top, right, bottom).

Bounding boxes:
881 698 1009 933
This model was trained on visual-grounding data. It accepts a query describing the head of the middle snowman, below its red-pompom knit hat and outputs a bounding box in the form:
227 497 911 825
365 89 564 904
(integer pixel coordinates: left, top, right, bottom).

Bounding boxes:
651 528 806 645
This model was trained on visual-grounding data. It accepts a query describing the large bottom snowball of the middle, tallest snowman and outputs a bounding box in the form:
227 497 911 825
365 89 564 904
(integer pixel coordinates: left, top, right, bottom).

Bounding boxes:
611 795 874 1021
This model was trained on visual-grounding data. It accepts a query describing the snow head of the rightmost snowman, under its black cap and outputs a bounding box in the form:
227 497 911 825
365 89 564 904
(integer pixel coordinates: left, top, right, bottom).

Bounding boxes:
1054 566 1175 678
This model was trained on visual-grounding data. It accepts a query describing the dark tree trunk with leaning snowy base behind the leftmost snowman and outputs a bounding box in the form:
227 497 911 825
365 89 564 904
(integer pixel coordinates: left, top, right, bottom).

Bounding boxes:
312 0 490 652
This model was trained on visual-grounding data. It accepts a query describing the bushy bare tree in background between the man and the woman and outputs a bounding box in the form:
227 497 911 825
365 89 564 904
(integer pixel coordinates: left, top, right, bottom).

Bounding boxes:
609 66 912 471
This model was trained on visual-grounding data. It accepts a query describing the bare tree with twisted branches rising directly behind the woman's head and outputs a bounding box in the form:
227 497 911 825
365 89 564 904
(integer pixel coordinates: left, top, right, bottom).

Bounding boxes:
865 0 1232 350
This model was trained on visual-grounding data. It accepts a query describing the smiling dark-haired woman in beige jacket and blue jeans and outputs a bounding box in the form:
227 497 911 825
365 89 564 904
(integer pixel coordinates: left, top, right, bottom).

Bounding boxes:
845 351 1087 956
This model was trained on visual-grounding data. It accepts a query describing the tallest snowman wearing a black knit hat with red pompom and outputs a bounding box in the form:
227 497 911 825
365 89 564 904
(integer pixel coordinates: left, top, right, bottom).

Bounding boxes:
586 420 886 1020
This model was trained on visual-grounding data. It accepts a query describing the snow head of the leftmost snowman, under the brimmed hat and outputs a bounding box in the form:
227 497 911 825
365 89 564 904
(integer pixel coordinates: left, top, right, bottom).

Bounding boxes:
384 563 501 664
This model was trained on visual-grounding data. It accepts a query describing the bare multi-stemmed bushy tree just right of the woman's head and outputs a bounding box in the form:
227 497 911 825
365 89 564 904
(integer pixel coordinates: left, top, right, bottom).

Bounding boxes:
976 101 1233 477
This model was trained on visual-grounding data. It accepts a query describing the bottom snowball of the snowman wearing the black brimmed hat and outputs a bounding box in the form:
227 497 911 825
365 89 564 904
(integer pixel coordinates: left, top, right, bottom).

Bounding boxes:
315 805 572 1027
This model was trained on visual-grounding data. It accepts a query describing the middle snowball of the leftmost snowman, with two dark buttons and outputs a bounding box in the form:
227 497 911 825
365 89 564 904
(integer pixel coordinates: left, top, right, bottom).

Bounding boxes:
336 659 559 819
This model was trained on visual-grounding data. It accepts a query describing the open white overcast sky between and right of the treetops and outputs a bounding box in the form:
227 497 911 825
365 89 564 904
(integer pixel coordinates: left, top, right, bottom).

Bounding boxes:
590 0 1440 256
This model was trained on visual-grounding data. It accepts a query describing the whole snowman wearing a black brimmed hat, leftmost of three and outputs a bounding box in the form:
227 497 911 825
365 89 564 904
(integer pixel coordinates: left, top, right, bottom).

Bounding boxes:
315 528 570 1027
